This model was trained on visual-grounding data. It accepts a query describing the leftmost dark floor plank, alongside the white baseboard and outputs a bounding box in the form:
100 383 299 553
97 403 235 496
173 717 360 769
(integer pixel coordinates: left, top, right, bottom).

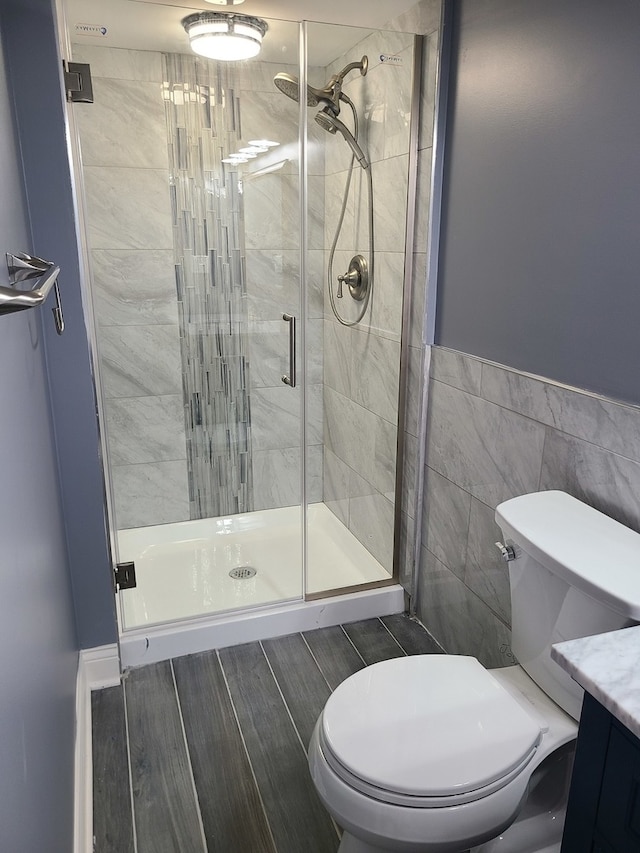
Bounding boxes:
91 684 134 853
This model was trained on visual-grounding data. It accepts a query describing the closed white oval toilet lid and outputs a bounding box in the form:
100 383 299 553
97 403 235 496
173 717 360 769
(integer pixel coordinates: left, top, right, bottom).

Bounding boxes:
322 655 542 798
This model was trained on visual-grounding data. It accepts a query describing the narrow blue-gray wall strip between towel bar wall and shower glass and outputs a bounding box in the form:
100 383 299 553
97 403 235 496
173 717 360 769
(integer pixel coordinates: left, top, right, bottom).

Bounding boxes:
1 0 116 648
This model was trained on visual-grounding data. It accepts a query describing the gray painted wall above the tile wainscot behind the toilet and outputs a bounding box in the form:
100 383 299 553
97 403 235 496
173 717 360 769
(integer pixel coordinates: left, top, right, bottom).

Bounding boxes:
436 0 640 402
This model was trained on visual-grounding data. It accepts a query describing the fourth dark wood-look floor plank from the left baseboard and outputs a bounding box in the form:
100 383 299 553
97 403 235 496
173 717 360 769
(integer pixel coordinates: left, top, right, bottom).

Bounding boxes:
220 643 338 853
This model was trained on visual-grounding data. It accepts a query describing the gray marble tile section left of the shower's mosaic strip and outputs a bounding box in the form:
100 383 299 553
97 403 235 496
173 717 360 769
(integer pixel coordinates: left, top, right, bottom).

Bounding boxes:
74 46 190 528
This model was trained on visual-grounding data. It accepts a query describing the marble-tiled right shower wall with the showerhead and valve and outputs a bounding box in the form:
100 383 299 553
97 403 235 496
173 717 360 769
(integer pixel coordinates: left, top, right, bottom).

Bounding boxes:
318 0 440 576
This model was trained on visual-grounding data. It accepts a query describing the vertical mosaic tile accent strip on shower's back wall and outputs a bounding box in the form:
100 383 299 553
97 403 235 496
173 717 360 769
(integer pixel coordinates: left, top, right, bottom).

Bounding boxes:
163 54 253 518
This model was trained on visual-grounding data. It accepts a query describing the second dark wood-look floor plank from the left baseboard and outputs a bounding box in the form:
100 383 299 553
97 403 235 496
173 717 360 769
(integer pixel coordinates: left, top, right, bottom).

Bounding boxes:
125 661 204 853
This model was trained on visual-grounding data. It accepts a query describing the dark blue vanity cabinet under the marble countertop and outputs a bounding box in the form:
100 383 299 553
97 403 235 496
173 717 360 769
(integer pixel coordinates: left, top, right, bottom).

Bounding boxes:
561 694 640 853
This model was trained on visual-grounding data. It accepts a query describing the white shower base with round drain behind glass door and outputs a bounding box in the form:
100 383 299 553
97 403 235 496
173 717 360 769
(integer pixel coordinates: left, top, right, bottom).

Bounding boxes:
118 504 404 667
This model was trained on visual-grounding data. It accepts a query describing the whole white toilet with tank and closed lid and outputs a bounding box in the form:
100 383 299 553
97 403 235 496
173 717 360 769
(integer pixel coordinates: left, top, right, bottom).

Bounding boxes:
309 491 640 853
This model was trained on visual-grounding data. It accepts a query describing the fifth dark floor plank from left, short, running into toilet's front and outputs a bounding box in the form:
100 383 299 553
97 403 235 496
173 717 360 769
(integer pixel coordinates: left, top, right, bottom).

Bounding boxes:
262 634 331 748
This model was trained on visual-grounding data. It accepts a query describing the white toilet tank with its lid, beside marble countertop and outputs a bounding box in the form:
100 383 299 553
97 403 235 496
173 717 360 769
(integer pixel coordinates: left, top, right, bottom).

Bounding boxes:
496 491 640 720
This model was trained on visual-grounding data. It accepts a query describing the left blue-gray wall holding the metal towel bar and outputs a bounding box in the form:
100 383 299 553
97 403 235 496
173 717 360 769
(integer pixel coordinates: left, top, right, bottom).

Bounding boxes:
0 11 78 853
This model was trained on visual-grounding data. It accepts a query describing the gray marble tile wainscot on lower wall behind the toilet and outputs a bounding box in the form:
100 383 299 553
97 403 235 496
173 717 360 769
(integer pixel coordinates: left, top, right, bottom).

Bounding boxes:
417 347 640 666
